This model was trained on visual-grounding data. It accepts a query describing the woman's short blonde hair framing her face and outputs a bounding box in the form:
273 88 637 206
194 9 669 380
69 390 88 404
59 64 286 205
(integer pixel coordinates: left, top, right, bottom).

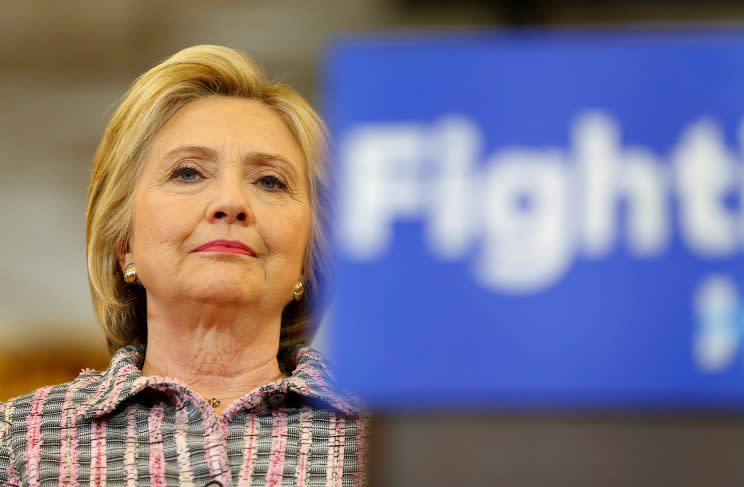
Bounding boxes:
86 45 328 353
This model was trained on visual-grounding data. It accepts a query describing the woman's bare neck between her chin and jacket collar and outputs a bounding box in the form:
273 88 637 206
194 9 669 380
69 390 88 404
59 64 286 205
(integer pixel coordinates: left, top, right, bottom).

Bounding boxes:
142 299 284 413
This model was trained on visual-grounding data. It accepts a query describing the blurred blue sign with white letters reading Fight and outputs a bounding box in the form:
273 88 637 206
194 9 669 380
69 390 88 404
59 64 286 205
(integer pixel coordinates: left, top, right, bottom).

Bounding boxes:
326 31 744 409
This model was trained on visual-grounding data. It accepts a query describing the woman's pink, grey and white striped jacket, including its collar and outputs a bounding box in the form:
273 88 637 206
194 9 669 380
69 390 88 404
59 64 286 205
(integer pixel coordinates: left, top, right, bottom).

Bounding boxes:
0 345 367 487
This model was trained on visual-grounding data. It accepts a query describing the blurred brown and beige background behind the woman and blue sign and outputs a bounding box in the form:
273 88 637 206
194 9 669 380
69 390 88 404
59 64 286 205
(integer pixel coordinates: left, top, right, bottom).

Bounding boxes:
0 0 744 486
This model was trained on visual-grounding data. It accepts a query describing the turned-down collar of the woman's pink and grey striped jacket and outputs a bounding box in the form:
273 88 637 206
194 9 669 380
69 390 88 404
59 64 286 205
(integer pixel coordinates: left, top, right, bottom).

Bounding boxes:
71 345 365 419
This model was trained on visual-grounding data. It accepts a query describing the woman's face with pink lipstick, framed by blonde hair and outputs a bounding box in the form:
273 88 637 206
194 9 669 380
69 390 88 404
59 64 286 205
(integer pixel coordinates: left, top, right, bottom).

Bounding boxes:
120 96 311 313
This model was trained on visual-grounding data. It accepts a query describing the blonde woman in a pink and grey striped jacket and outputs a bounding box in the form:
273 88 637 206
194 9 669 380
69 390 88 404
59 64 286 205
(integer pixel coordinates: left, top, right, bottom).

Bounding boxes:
0 46 366 486
